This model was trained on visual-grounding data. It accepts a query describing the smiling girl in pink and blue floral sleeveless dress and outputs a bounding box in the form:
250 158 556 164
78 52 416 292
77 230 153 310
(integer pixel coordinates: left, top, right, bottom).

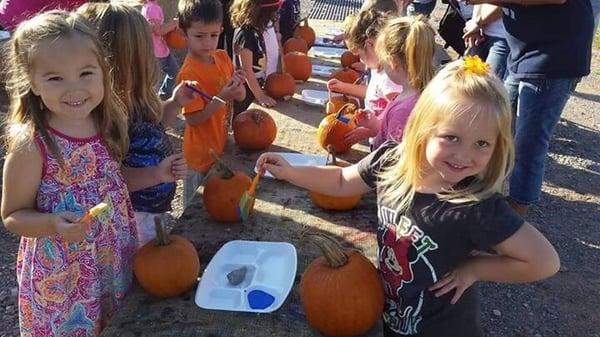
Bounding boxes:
1 11 137 336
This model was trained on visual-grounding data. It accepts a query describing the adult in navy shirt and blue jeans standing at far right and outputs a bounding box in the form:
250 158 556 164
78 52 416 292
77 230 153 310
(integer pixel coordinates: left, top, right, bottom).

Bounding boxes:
467 0 594 214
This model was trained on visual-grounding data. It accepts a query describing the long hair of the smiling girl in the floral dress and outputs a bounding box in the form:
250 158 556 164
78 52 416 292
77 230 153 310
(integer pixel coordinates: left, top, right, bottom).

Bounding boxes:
5 10 129 164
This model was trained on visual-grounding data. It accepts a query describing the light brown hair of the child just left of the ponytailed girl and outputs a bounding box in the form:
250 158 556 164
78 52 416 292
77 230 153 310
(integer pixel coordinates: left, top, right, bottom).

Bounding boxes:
344 8 393 53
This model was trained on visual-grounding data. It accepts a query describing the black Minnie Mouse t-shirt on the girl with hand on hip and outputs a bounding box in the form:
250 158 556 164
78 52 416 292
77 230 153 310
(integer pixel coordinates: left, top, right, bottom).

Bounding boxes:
357 142 524 337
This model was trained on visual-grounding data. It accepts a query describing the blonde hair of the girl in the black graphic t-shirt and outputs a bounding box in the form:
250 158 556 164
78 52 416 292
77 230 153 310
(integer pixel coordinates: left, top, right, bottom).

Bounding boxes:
379 60 514 211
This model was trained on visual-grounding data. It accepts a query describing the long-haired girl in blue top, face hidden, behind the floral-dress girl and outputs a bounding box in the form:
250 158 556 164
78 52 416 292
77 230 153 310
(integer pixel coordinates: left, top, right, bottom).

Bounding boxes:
79 3 191 246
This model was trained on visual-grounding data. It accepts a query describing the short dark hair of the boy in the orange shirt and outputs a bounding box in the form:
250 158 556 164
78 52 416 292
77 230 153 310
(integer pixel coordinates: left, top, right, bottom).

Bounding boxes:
177 0 223 32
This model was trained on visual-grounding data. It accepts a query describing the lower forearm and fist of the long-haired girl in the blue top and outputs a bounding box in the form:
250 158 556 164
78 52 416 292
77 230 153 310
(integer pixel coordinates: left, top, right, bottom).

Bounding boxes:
121 153 187 193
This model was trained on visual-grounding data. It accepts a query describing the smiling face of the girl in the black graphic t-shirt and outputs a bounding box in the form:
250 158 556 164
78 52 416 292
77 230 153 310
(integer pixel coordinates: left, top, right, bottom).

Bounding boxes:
425 107 498 188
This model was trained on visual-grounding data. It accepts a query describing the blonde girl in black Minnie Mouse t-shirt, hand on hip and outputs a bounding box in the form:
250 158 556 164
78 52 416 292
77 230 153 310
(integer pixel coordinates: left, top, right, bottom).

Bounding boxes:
258 58 559 337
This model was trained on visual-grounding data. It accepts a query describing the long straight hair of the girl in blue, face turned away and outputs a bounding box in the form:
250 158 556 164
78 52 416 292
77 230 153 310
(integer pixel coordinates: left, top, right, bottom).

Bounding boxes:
77 3 162 123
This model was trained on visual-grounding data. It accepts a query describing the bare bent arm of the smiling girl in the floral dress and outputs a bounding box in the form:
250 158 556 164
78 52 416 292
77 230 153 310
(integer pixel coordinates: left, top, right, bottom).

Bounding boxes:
1 144 86 242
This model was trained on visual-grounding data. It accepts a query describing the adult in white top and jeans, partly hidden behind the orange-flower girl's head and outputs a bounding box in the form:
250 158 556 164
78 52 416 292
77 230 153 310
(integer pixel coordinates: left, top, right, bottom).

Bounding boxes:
463 4 510 80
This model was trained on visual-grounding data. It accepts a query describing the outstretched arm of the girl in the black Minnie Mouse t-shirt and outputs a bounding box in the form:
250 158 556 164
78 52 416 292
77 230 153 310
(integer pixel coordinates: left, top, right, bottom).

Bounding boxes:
257 153 371 196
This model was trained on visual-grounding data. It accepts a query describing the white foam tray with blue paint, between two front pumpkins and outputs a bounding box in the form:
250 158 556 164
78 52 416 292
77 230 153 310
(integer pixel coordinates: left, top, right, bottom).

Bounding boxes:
195 240 298 313
